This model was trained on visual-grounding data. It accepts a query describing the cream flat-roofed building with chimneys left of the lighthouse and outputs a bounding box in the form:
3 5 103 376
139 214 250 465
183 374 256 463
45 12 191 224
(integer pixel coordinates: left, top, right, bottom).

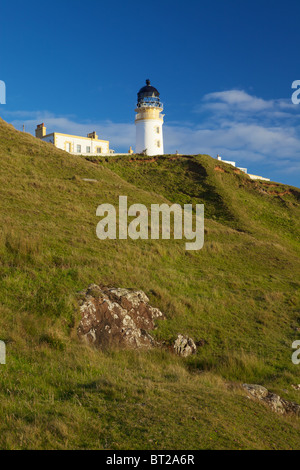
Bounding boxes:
35 123 113 155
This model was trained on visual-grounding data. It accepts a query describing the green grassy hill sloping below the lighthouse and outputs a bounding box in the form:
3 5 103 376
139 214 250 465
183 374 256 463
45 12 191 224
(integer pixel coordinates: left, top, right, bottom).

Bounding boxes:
0 116 300 449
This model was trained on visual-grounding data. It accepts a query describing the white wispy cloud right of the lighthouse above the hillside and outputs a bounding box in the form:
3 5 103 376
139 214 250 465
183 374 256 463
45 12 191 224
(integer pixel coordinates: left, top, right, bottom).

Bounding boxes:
179 90 300 180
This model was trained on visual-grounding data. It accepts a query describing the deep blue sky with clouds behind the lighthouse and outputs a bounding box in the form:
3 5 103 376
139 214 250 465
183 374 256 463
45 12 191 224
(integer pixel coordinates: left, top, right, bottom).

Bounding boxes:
0 0 300 186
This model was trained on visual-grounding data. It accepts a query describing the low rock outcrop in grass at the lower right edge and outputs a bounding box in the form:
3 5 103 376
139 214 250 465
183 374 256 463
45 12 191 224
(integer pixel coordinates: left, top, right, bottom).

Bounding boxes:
243 384 300 416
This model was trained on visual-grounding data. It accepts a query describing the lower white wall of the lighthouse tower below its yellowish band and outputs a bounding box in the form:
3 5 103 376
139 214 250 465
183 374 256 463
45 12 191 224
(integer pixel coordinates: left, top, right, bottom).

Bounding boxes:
135 119 164 156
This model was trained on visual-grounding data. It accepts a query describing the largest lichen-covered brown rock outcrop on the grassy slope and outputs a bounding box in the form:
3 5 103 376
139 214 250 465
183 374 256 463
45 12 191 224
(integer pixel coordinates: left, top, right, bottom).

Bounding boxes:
77 284 164 349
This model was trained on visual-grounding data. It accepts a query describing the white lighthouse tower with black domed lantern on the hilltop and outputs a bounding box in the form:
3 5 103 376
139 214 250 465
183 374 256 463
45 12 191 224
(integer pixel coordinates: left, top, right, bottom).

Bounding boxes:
135 80 164 156
